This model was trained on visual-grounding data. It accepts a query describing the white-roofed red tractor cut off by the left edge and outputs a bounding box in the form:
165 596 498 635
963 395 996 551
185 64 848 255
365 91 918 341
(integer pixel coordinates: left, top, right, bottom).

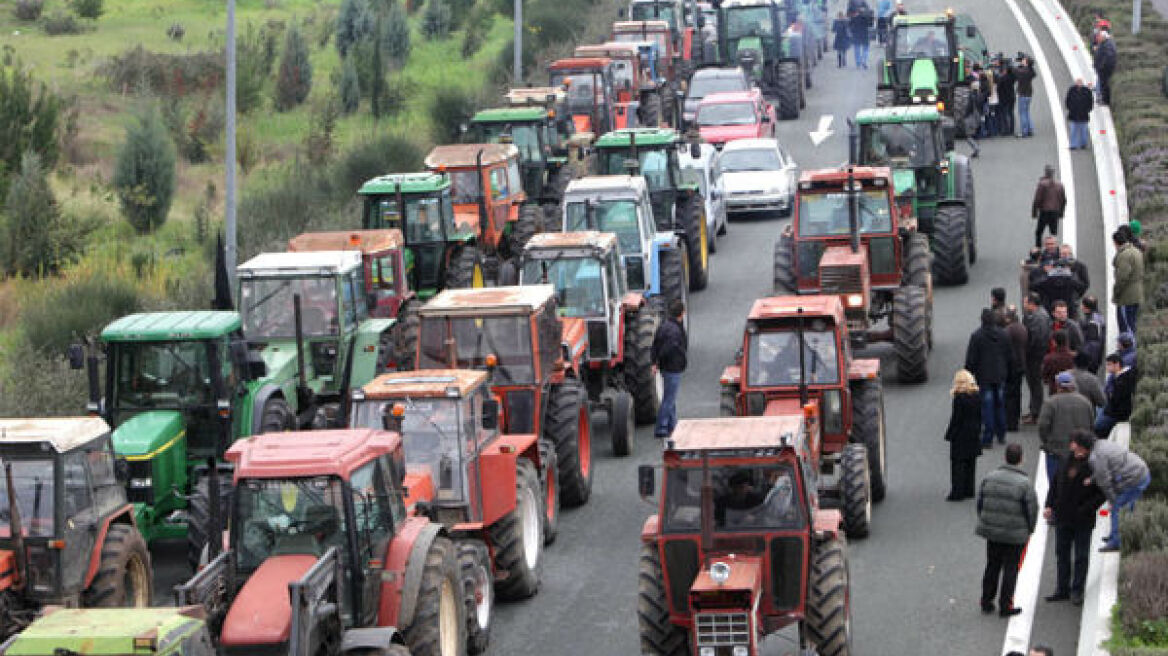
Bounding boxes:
0 417 154 639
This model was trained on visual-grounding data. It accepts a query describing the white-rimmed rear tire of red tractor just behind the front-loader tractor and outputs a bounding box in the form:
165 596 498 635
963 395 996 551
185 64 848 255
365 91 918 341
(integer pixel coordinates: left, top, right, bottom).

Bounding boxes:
487 458 544 600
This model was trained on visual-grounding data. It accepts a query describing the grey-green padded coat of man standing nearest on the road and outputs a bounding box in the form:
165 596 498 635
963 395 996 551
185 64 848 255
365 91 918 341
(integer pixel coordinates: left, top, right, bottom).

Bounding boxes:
976 465 1038 545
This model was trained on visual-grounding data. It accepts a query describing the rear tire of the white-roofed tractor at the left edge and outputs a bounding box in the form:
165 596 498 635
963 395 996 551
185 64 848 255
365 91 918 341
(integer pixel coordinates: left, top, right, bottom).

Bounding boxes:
82 524 154 608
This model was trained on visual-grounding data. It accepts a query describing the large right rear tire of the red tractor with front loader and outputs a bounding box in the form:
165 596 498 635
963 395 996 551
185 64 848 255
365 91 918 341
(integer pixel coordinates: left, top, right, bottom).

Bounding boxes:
402 537 466 656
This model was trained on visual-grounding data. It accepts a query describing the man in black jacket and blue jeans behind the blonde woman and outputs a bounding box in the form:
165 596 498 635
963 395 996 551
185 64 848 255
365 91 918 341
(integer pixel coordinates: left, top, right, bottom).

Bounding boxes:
965 307 1017 446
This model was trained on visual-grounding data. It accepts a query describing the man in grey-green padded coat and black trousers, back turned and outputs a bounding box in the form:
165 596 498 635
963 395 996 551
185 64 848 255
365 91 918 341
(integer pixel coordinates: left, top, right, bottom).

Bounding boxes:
978 444 1038 617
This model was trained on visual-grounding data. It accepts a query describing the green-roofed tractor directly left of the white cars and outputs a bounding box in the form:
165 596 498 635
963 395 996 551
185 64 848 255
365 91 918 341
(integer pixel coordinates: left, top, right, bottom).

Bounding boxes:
596 127 710 292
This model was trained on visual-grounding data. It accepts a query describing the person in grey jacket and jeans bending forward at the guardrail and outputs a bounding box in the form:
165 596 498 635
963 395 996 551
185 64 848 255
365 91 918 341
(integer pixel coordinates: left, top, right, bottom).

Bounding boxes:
1071 431 1152 553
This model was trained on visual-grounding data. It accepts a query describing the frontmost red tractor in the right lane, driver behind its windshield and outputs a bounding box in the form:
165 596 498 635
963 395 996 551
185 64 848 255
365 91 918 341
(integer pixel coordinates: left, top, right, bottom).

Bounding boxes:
637 415 851 656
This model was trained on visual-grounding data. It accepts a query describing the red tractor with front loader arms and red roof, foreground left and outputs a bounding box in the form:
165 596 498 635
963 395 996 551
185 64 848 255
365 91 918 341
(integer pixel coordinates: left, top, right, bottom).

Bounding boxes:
175 428 466 656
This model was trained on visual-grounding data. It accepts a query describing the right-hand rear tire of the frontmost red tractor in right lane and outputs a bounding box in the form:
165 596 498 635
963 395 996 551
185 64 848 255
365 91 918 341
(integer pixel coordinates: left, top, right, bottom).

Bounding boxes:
805 537 851 656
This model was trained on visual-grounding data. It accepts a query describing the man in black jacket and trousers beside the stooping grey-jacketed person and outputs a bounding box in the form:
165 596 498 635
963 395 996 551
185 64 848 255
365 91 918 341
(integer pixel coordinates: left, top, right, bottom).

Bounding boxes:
1042 443 1105 606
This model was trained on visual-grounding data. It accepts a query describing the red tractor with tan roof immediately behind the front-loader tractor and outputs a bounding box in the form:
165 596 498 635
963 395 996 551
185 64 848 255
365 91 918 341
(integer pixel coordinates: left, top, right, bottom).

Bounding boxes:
352 370 559 654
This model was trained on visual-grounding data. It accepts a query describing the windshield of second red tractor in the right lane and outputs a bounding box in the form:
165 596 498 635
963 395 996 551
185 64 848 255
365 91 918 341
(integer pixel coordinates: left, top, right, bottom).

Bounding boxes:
746 330 840 388
